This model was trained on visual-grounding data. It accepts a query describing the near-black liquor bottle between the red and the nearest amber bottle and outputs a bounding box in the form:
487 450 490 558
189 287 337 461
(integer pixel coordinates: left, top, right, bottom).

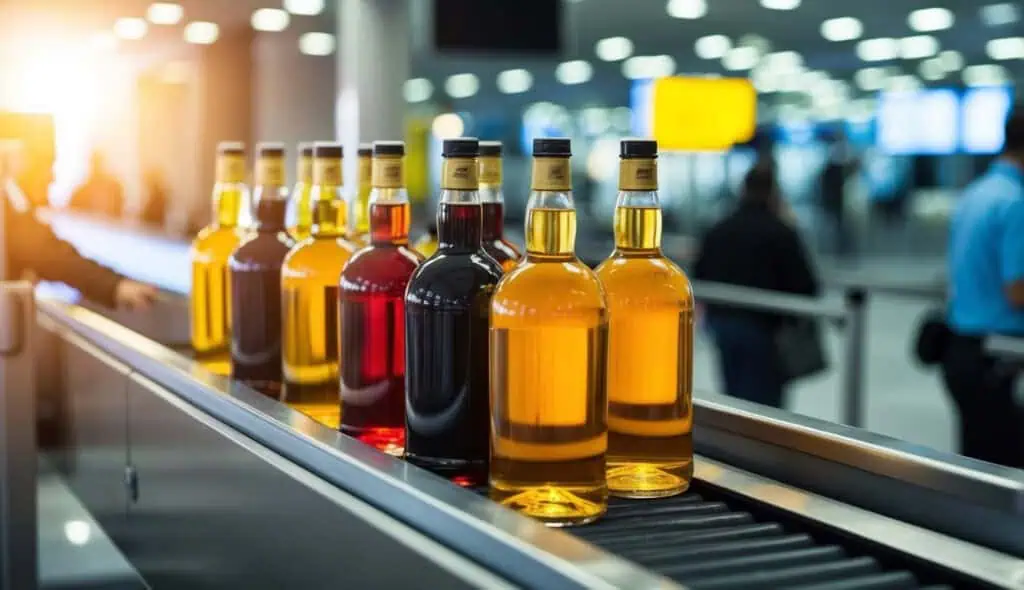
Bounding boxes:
406 138 502 486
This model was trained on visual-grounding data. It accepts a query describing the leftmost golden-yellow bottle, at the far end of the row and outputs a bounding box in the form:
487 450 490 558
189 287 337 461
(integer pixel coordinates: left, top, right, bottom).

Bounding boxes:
189 141 249 375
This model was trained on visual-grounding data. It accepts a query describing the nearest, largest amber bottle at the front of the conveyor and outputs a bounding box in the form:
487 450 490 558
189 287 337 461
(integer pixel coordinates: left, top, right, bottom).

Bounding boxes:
490 138 608 526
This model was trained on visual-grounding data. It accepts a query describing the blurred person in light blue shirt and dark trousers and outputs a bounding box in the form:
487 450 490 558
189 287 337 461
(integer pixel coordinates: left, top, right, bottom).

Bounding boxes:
942 109 1024 467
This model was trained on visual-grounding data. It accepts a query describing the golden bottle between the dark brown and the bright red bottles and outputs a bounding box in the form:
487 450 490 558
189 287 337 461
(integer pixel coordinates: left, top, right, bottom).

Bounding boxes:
281 142 355 428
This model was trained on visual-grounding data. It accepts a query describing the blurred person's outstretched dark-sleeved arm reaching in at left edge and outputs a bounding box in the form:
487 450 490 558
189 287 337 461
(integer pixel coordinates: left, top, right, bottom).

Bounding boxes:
0 144 157 309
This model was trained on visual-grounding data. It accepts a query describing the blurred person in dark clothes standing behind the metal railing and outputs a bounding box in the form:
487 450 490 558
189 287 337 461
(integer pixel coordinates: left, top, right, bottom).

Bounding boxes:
693 161 819 408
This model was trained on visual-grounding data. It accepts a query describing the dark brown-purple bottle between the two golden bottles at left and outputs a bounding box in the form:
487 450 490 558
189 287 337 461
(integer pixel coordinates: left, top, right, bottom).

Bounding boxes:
228 143 295 397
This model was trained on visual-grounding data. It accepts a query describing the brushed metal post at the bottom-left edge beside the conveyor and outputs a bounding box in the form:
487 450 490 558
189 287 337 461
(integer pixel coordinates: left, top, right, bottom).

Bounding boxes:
0 280 39 590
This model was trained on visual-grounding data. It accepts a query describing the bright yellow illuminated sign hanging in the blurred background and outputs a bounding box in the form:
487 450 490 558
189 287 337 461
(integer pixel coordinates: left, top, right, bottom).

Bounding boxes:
651 77 758 152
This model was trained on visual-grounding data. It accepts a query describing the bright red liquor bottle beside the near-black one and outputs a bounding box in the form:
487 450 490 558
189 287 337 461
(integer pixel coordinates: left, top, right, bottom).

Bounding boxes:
340 141 423 455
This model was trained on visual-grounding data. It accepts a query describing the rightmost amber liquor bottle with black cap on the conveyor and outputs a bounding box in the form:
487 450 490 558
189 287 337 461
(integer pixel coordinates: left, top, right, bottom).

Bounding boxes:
597 139 693 498
